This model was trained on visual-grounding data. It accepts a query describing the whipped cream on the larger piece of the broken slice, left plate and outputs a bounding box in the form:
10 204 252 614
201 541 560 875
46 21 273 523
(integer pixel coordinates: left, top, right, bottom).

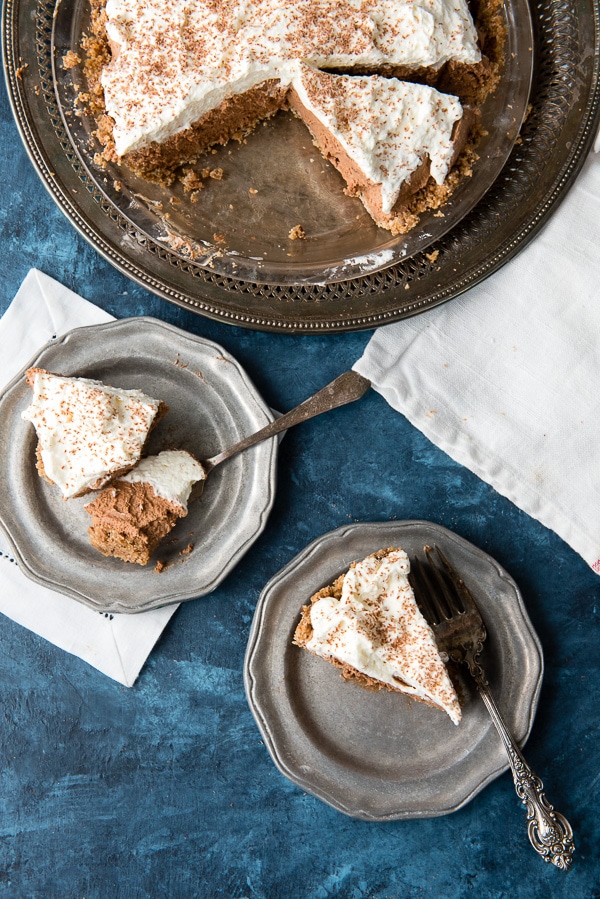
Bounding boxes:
22 370 160 499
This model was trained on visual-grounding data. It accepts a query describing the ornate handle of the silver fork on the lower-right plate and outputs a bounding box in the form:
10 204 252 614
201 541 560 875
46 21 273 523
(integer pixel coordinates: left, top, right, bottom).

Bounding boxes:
464 658 575 871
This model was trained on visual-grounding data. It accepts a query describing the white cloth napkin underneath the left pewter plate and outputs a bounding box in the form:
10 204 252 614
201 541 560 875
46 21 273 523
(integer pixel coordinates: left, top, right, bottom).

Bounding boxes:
0 269 177 687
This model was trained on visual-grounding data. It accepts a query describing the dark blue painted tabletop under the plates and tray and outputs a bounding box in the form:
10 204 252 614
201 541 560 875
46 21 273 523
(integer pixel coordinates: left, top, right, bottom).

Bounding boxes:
0 72 600 899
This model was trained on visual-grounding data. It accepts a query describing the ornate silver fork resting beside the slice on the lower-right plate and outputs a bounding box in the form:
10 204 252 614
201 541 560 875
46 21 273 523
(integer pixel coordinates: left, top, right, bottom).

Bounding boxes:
409 546 575 871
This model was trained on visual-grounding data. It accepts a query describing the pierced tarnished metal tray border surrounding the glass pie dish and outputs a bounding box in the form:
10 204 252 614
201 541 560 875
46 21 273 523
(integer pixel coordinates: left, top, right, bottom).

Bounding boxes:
2 0 600 333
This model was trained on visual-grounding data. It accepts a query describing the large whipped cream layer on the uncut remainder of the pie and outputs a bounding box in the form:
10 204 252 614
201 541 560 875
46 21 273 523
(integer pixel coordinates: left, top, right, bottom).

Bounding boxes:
102 0 481 156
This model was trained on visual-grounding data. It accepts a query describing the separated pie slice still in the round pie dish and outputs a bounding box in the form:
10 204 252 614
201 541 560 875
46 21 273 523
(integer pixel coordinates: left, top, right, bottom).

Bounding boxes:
289 66 468 233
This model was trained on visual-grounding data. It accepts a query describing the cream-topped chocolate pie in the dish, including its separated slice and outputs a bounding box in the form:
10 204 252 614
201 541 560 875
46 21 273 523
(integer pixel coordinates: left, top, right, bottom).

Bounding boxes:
85 0 502 233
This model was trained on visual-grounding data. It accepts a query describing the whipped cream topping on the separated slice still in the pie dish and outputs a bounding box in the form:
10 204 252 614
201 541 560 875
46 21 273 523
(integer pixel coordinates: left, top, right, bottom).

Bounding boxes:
293 66 463 214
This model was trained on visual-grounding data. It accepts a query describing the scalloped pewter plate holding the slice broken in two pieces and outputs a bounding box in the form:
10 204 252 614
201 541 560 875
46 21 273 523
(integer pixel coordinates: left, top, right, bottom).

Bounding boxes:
0 318 277 612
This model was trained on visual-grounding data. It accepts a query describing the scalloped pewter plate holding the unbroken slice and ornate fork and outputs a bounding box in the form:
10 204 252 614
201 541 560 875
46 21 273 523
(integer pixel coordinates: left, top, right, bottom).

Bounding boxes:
244 521 543 821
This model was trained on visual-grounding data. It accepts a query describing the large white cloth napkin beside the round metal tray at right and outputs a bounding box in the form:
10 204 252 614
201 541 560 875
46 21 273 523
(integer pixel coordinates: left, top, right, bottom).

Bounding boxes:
354 140 600 574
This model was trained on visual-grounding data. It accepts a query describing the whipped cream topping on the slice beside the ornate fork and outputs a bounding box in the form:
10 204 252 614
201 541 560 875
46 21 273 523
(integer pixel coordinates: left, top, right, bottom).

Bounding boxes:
306 549 461 724
